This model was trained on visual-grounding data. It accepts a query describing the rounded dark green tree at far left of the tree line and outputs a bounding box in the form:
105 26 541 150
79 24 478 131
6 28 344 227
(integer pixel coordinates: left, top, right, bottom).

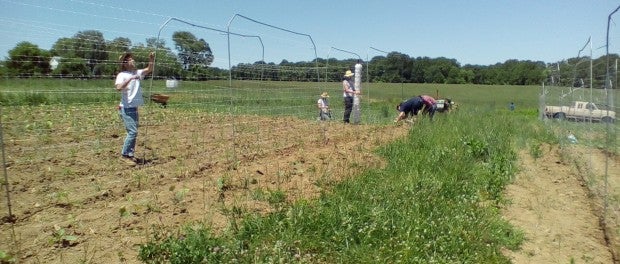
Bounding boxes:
6 41 51 77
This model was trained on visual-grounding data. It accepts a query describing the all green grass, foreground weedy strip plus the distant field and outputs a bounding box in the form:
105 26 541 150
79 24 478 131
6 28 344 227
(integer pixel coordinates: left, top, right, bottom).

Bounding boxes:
0 79 617 263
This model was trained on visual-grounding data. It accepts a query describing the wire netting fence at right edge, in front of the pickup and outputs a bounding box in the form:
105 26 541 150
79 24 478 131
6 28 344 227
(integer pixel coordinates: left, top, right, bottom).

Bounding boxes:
539 32 620 256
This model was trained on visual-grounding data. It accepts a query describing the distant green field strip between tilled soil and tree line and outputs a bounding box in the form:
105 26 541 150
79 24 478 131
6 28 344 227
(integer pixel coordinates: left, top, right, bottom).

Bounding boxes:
0 79 541 123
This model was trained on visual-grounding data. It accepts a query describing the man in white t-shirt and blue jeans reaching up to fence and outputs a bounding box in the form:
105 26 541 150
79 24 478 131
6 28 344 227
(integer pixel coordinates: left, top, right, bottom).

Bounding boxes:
114 52 155 165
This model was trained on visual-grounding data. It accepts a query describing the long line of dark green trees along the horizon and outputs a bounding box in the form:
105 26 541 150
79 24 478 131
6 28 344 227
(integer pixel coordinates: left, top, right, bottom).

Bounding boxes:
0 30 618 88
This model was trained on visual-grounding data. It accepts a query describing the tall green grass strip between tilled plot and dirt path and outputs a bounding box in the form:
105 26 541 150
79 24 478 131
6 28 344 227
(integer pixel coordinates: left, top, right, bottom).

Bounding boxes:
140 108 553 263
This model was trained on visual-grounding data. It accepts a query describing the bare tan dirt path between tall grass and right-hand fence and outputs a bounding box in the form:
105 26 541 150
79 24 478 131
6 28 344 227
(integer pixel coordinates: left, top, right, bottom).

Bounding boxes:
504 146 620 264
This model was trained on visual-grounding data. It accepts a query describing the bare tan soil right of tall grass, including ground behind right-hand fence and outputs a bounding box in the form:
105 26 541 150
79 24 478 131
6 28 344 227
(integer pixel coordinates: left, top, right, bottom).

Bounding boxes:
503 145 620 263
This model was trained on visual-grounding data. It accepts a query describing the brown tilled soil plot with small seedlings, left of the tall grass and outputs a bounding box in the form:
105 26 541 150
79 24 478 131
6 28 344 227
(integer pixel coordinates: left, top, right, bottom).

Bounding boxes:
0 114 407 263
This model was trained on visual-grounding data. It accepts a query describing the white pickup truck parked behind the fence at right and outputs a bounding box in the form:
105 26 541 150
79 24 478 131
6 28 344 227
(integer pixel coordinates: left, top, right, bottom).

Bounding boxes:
545 101 616 123
